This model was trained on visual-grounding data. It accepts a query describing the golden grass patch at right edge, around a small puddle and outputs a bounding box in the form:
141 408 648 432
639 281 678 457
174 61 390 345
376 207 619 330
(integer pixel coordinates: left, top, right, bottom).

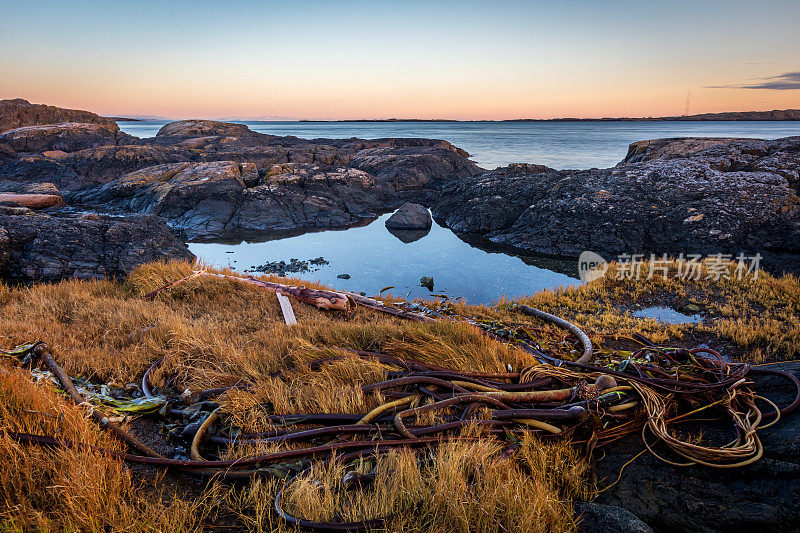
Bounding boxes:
521 262 800 363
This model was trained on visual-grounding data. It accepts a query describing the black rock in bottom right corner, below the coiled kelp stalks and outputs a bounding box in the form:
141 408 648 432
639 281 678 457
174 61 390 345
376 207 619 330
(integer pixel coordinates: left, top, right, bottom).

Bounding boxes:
596 363 800 533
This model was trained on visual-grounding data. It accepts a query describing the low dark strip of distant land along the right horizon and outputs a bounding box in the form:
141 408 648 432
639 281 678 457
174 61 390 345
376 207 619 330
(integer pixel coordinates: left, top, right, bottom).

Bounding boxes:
300 109 800 122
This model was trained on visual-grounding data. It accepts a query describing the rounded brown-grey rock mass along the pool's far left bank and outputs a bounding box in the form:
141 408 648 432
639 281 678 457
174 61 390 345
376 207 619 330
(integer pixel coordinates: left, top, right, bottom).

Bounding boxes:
72 161 391 236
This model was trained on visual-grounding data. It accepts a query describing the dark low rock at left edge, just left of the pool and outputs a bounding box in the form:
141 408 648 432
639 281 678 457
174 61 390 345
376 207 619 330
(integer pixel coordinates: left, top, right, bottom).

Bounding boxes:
0 208 194 282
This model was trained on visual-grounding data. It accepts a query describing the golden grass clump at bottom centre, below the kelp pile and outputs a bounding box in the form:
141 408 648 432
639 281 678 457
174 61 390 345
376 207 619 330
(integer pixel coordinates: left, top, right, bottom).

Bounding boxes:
212 429 587 533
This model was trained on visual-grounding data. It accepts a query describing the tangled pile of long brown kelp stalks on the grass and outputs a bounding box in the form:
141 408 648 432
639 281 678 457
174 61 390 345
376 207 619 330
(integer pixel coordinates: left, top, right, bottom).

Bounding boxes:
3 268 800 530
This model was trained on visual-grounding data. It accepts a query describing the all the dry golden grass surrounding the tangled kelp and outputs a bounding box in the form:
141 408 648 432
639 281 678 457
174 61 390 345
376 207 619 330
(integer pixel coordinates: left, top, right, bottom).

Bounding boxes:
0 263 800 531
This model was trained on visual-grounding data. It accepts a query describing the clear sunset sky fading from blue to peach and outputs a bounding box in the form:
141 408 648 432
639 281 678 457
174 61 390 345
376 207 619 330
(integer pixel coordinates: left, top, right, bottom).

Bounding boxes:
0 0 800 120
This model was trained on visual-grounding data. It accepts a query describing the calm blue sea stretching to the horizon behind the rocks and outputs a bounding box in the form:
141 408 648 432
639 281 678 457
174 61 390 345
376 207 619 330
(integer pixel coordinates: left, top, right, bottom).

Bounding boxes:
119 121 800 169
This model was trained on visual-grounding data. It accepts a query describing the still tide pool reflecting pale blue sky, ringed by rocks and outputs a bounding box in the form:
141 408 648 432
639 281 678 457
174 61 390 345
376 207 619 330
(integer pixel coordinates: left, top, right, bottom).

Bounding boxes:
189 214 581 304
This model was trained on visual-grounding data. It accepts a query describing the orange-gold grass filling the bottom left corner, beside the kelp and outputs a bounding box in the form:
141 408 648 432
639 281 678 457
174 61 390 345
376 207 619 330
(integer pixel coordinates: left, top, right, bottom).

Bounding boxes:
0 361 209 531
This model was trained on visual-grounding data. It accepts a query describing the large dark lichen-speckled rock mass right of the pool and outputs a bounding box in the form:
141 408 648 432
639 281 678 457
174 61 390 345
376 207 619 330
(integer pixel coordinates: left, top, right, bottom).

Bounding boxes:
433 137 800 265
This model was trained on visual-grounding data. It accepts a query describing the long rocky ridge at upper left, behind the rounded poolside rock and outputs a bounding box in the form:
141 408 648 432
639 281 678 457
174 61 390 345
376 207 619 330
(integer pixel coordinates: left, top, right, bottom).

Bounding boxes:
0 101 479 193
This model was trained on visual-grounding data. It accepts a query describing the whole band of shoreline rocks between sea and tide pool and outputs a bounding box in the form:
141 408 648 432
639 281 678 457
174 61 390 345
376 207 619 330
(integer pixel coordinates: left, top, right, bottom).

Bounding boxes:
0 100 800 282
